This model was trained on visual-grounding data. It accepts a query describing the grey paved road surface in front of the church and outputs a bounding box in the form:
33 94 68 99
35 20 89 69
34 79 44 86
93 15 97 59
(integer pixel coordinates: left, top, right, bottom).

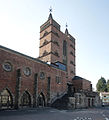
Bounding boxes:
0 107 109 120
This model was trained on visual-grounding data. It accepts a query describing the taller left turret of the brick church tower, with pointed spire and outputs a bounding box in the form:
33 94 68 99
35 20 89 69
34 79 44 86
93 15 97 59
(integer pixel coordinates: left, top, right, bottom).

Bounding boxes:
39 13 60 63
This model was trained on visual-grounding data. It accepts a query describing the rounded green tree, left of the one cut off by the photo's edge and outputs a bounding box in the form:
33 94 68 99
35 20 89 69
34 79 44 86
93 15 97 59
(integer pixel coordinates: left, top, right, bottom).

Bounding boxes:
96 77 107 92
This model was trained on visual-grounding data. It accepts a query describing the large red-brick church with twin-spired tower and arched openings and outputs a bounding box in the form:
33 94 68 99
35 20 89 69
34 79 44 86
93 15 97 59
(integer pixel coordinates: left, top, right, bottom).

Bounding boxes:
0 13 100 109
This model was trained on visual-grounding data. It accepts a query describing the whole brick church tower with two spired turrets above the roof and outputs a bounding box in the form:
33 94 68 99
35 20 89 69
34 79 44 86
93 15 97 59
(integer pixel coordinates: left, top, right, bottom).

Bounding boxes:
39 13 75 78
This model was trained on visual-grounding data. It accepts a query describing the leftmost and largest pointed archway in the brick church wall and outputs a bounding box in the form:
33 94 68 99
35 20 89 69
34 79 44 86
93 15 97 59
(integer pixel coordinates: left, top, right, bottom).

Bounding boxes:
0 89 13 109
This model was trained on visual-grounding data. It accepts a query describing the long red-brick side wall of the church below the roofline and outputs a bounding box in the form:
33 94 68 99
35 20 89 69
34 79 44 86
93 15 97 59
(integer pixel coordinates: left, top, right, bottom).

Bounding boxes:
0 48 67 105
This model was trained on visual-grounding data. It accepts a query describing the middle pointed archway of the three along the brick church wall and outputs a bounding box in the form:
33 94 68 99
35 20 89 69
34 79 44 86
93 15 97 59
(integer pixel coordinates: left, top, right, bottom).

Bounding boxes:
21 91 31 107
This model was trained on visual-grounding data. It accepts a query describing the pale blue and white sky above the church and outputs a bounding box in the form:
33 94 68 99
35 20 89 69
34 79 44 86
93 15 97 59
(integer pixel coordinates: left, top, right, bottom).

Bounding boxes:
0 0 109 89
